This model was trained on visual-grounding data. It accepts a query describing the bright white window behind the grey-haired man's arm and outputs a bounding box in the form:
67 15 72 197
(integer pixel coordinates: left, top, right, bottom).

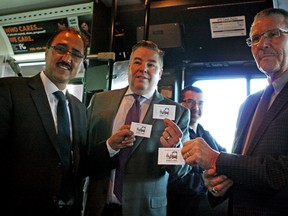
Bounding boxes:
193 78 267 152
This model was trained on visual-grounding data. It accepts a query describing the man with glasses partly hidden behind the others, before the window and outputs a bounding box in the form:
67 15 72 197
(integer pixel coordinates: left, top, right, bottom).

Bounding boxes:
167 86 226 216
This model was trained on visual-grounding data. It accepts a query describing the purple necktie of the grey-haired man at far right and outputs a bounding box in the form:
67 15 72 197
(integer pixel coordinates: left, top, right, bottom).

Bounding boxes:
242 84 274 154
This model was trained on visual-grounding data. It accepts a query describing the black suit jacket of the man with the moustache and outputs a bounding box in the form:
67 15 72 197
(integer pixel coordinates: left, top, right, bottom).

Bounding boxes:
0 74 87 216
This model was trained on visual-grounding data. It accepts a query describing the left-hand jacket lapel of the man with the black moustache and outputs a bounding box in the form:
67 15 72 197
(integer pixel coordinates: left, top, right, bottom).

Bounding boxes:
28 74 60 156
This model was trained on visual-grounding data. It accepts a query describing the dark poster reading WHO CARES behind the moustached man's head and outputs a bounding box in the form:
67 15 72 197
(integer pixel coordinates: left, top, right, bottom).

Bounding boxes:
3 15 92 54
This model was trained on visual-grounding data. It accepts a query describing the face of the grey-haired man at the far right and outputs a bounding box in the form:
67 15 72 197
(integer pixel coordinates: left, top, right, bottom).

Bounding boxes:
250 14 288 81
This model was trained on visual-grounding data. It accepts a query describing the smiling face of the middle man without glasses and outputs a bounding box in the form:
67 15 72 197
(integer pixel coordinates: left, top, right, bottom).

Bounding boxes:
128 47 163 95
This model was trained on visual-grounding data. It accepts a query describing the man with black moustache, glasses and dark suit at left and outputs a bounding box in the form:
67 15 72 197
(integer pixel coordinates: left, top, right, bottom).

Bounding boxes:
0 28 87 216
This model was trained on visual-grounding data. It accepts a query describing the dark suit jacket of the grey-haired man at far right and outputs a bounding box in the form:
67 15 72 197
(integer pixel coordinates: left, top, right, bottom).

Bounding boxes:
209 84 288 216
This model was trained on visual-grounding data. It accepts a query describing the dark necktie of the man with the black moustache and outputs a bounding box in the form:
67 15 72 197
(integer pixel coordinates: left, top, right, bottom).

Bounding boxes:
53 91 72 201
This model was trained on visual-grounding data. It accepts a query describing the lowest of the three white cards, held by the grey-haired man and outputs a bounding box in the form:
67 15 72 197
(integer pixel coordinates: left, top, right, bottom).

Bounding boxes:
158 147 185 165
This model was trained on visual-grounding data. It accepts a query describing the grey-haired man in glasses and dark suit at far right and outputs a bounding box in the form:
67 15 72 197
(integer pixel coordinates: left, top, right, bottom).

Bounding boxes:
178 8 288 216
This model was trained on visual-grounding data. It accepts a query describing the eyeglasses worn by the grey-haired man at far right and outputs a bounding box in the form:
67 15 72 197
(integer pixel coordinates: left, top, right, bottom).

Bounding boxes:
246 29 288 47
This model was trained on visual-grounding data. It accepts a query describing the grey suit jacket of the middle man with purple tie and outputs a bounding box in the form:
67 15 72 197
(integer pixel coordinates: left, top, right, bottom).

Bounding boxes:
84 88 190 216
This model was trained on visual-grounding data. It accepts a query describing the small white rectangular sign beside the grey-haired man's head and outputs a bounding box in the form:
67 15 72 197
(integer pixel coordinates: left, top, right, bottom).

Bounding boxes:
210 16 246 38
